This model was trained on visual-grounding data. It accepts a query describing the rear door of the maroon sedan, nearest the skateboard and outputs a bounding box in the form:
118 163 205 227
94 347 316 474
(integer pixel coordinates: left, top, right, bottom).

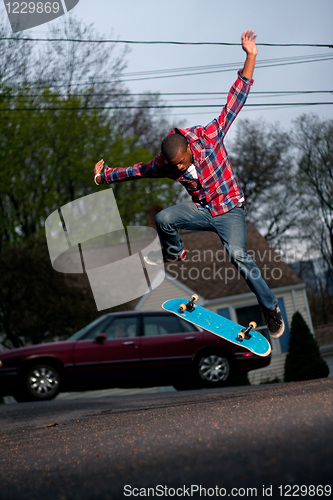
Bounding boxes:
140 313 200 377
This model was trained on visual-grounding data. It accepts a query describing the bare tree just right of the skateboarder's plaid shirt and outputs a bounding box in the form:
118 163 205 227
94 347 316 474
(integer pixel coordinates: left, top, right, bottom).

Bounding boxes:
230 120 297 247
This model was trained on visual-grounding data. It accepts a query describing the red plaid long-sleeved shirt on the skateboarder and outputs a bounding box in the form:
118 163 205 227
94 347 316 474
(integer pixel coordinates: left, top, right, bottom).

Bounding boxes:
103 71 253 216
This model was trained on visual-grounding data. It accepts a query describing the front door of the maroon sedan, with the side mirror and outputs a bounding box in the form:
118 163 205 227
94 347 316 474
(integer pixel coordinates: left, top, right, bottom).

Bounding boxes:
73 315 140 388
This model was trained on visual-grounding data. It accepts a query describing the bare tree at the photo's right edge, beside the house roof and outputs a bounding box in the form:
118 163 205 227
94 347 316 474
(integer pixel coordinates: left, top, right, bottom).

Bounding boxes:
294 114 333 320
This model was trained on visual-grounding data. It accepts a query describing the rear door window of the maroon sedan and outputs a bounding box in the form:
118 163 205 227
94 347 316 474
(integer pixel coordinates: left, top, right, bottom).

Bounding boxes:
143 314 197 337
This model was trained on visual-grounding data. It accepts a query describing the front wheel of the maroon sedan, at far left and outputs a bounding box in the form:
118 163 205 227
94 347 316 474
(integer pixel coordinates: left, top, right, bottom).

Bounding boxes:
14 362 61 402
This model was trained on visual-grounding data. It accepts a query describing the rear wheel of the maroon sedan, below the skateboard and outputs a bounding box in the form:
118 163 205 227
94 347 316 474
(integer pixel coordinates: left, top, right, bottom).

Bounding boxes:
196 351 231 387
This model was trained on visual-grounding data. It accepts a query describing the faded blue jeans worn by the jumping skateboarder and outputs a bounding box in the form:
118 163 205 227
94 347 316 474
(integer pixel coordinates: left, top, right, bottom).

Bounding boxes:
156 202 278 310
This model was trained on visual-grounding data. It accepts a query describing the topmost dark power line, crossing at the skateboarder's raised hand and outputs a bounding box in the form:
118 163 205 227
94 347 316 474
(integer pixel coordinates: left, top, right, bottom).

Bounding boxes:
0 37 333 49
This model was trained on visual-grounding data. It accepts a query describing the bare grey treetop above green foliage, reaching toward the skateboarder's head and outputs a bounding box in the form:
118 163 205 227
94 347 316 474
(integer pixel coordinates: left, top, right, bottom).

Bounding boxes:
36 17 176 154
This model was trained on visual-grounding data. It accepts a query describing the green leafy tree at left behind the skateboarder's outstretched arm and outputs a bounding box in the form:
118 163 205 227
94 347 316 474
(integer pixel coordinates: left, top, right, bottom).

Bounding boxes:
0 87 179 245
